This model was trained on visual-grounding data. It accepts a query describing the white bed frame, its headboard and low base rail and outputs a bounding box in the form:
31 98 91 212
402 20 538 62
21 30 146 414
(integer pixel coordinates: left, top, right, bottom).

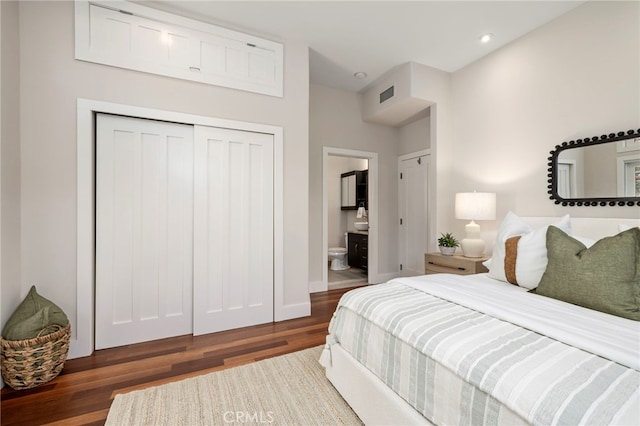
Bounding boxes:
326 217 640 425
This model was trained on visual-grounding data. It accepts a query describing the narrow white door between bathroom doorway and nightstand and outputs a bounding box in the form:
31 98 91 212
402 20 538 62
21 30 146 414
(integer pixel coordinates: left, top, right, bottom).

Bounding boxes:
399 155 429 276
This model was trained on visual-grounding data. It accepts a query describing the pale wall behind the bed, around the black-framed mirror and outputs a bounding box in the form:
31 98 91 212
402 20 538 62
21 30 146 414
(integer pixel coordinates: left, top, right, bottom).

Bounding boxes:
450 1 640 240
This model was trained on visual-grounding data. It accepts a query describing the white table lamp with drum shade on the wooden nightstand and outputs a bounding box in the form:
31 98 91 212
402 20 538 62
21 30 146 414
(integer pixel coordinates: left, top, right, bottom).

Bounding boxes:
455 192 496 257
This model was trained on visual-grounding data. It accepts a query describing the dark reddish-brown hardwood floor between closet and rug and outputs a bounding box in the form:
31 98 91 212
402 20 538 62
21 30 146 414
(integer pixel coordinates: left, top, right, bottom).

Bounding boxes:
0 289 349 425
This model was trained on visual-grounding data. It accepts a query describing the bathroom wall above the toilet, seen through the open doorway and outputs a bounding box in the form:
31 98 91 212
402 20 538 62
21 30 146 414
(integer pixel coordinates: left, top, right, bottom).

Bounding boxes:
325 155 368 248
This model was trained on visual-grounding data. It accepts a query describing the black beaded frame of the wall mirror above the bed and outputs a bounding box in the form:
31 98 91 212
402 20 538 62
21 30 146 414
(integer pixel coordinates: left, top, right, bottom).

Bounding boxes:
547 129 640 206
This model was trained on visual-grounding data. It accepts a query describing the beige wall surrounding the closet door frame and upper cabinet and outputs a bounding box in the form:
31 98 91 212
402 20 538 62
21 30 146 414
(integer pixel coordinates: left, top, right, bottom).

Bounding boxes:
13 1 309 352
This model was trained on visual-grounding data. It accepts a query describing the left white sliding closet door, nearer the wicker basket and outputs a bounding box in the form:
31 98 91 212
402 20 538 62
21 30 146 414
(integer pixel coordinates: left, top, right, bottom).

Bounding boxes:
95 114 193 349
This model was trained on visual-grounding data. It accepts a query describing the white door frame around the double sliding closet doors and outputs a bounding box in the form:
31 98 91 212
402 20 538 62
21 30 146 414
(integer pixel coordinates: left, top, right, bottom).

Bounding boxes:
76 98 288 358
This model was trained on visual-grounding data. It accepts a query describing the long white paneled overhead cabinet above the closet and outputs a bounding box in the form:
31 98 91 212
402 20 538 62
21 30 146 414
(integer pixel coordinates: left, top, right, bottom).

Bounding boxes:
75 1 284 97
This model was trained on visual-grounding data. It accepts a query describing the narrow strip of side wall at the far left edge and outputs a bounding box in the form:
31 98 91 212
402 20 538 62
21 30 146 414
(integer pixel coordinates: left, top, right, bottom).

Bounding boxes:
0 1 21 330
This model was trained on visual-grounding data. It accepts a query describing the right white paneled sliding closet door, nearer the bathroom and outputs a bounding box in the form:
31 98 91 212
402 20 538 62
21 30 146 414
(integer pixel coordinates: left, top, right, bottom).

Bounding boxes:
193 126 273 335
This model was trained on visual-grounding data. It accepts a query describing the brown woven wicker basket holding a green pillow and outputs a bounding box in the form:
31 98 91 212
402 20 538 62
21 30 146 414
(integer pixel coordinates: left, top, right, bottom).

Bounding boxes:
0 325 71 389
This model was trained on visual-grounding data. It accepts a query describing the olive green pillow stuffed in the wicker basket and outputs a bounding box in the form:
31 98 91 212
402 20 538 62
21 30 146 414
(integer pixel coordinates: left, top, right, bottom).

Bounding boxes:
2 286 69 340
